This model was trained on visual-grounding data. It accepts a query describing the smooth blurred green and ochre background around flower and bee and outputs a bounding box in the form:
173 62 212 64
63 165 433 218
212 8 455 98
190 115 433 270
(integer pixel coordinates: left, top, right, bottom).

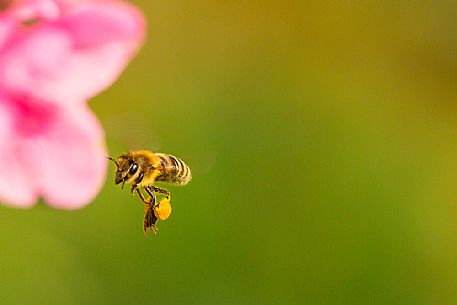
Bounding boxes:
0 0 457 305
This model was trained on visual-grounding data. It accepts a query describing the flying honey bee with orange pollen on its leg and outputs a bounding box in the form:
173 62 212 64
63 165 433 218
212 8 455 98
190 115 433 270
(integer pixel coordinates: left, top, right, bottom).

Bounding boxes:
108 150 192 236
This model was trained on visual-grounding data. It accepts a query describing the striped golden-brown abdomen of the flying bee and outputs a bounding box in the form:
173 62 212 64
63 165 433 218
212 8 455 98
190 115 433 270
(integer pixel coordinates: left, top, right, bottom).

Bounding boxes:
155 153 192 185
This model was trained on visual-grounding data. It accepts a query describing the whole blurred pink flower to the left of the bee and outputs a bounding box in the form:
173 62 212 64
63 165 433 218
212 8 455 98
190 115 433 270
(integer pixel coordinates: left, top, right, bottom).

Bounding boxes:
0 0 144 209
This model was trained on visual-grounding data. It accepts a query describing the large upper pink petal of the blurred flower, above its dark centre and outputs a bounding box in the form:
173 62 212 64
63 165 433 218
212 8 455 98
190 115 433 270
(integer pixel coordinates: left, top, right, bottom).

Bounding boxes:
0 0 144 102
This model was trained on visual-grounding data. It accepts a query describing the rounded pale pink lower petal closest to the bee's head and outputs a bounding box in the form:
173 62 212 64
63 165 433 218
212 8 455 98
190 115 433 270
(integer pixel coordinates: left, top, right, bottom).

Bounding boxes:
34 105 107 209
